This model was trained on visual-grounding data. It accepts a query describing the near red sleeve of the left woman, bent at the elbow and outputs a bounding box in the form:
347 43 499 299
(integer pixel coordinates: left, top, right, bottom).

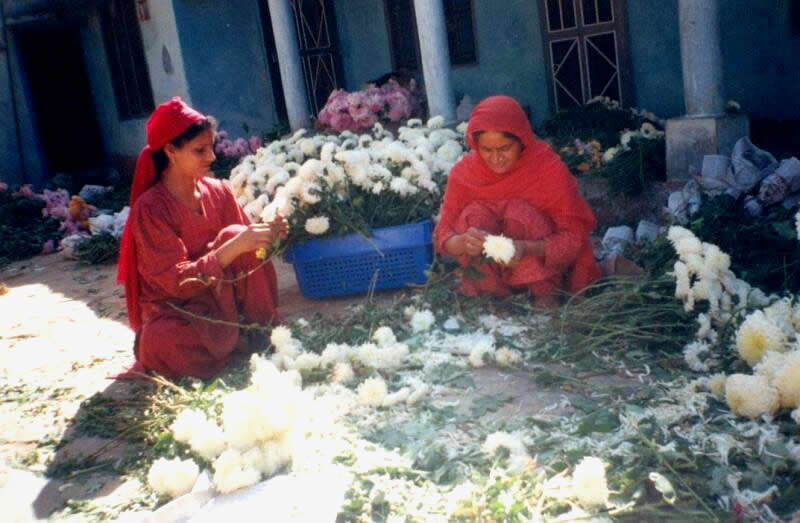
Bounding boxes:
133 202 224 299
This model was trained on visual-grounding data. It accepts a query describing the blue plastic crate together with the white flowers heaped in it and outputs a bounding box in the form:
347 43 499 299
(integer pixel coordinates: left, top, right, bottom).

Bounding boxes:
230 117 465 298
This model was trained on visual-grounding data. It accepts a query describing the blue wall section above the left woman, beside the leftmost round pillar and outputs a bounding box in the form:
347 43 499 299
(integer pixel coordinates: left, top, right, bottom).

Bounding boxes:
170 0 280 137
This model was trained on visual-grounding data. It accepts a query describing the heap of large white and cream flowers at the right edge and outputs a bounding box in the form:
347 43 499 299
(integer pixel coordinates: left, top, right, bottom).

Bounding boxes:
668 226 800 423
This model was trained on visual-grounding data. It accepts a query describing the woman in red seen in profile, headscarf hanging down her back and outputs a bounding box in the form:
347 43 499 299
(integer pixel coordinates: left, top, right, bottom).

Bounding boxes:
118 97 287 378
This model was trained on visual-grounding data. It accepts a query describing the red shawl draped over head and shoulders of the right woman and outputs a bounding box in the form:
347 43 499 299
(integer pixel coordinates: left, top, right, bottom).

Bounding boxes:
435 96 599 292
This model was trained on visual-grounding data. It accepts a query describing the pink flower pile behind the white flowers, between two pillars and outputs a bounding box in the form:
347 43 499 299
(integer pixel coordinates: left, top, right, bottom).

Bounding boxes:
317 80 420 132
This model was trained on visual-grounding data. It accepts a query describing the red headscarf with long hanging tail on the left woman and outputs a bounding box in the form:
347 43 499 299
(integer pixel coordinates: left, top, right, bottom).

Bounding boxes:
117 96 206 330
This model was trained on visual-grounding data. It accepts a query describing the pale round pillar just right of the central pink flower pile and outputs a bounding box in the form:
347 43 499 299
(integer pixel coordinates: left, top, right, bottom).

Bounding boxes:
414 0 456 123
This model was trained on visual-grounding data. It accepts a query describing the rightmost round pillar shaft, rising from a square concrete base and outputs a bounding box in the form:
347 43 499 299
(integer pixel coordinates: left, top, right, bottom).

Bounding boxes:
678 0 725 116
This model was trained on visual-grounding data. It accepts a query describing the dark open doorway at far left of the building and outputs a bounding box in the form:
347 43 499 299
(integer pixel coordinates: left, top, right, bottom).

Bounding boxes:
16 26 104 176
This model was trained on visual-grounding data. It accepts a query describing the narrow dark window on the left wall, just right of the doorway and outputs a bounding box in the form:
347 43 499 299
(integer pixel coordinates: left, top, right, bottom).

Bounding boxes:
101 0 155 120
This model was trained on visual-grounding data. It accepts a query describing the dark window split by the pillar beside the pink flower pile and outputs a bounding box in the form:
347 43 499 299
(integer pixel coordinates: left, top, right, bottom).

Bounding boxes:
385 0 477 71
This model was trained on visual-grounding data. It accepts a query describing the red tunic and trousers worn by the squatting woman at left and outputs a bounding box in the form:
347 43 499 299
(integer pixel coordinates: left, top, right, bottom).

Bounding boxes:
128 177 280 378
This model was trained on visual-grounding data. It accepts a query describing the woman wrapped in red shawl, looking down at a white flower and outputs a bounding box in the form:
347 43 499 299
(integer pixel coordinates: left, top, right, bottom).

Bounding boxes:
434 96 601 308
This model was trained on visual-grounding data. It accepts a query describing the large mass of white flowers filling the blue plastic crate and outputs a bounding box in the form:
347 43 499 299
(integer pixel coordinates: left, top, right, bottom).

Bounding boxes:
230 117 466 250
